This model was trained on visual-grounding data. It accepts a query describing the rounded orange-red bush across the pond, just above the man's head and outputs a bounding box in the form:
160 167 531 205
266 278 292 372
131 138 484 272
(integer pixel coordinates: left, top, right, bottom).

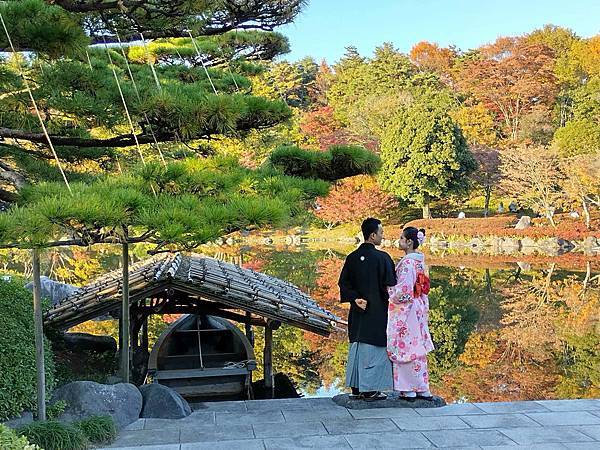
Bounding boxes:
315 175 398 226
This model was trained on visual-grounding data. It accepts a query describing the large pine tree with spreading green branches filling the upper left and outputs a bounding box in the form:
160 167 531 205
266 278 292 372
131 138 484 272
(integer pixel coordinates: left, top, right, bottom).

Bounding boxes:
0 0 378 251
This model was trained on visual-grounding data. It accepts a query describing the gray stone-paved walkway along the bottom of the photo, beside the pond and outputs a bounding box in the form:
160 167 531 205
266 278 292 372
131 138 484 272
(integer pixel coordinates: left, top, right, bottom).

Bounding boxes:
99 398 600 450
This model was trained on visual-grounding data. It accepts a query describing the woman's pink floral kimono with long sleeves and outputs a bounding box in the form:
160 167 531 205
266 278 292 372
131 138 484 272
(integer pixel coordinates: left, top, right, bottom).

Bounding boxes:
387 253 433 392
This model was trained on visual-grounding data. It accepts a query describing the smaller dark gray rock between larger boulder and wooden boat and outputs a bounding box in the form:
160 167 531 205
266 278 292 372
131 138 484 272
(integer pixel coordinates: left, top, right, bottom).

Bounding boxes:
140 383 192 419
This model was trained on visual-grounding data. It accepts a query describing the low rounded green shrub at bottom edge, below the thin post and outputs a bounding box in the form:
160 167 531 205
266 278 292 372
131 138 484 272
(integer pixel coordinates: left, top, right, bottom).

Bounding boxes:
18 420 89 450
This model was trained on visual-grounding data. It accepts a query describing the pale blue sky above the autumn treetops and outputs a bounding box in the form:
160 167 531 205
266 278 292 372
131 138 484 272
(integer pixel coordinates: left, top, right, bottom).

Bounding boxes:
278 0 600 63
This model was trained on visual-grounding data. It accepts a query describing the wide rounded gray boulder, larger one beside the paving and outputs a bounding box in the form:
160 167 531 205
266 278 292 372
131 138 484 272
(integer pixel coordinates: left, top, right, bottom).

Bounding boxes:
51 381 142 429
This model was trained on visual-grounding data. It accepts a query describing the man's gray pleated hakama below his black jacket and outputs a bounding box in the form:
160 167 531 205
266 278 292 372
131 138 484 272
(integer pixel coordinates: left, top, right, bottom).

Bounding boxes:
346 342 393 392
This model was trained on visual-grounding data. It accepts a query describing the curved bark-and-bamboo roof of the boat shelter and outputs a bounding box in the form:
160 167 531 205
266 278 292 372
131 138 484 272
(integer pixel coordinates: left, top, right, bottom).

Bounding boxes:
45 253 343 335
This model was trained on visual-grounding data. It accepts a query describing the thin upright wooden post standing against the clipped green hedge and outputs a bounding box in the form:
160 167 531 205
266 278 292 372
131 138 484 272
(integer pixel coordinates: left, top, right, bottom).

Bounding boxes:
33 248 46 421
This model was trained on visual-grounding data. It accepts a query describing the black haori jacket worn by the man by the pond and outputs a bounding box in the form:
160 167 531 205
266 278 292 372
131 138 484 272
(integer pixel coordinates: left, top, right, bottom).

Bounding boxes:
338 243 396 347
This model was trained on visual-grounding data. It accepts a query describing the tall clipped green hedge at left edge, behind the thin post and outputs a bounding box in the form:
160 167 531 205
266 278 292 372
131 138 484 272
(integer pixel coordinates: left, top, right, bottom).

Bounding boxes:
0 281 54 420
